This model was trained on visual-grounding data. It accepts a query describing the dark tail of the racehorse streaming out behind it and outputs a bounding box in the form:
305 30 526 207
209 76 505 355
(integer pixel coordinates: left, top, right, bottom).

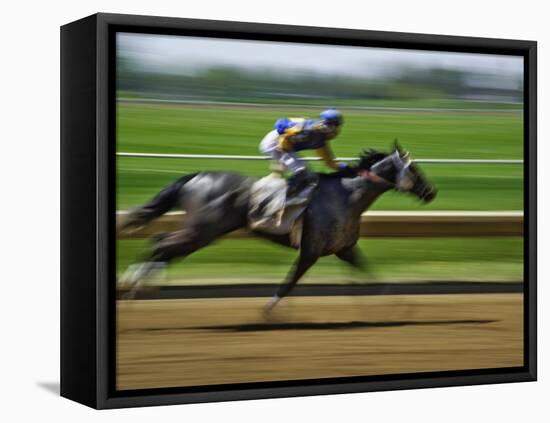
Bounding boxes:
119 173 198 230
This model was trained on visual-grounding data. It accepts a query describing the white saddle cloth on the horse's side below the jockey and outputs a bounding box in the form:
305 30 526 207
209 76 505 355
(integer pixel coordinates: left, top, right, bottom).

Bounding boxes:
248 173 317 247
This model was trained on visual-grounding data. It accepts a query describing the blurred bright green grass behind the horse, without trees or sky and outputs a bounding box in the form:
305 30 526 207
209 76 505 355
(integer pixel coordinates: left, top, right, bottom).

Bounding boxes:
117 102 523 284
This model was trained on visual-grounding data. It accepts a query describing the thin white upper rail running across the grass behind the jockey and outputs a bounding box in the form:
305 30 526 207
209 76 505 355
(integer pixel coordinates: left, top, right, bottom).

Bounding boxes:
116 152 523 164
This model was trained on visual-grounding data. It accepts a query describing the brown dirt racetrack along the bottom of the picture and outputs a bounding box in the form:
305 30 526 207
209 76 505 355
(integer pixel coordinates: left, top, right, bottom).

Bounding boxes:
117 293 523 390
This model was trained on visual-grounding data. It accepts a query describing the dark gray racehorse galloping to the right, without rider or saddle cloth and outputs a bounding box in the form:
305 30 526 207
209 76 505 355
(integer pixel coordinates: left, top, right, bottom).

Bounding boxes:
118 143 436 308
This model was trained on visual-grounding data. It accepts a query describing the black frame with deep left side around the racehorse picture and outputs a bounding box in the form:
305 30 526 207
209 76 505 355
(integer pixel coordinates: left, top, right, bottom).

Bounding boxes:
61 13 537 409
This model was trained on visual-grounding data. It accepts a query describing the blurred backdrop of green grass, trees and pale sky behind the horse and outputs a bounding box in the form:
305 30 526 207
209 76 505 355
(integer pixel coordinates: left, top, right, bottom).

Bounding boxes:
117 33 523 284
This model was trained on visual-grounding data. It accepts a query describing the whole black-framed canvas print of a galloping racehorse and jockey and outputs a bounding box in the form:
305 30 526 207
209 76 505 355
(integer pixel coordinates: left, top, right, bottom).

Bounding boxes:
61 14 536 408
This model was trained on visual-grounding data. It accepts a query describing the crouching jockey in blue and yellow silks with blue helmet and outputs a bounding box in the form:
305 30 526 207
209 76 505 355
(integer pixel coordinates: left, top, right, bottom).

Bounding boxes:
260 109 347 196
